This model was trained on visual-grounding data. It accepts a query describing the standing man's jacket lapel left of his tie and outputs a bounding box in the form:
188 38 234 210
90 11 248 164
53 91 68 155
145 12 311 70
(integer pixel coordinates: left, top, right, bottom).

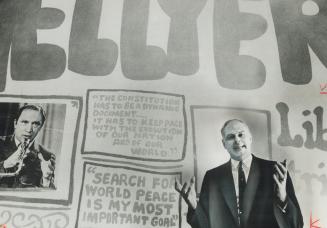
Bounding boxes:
219 160 238 224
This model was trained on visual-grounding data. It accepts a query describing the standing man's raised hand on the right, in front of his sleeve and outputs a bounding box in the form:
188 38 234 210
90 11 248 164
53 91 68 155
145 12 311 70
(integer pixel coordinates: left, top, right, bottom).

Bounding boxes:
273 160 288 203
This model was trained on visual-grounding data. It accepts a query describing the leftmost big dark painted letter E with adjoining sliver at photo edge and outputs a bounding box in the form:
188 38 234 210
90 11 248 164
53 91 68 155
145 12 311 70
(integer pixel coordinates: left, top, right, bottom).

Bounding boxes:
0 0 66 91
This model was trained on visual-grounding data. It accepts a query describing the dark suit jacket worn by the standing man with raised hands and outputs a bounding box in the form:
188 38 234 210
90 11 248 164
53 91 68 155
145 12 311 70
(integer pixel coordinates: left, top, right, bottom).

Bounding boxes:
187 156 303 228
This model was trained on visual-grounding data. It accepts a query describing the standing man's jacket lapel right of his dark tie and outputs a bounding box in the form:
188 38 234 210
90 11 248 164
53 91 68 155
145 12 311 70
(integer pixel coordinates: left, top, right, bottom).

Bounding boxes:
242 156 260 224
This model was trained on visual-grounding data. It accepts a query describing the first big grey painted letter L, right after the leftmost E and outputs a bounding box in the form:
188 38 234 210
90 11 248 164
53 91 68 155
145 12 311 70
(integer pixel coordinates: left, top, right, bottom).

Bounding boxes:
68 0 118 76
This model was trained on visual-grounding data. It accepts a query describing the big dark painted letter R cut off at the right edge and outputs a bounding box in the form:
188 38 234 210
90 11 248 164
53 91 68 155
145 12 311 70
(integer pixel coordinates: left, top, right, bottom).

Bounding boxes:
270 0 327 85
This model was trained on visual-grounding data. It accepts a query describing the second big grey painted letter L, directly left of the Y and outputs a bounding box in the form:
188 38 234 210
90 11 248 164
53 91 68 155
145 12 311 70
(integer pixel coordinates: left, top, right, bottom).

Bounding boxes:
120 0 168 80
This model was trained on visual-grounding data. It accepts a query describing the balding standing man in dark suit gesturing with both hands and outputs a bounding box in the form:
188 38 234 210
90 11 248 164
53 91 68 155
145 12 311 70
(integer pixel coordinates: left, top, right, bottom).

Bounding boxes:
175 119 303 228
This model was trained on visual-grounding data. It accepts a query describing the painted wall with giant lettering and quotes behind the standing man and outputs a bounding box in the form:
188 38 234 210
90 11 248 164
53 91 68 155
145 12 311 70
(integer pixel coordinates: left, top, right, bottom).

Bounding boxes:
0 0 327 227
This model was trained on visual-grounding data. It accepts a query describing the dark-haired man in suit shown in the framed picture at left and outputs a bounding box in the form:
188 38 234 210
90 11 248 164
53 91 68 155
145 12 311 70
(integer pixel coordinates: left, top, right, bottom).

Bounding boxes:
0 105 55 188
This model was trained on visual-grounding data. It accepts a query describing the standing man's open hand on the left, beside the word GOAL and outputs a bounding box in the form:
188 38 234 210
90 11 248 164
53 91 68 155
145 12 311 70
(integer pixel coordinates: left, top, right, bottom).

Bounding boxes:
175 177 197 209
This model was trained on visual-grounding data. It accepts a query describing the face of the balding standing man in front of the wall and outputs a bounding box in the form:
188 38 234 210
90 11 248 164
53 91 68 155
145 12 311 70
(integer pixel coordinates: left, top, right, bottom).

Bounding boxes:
222 120 252 161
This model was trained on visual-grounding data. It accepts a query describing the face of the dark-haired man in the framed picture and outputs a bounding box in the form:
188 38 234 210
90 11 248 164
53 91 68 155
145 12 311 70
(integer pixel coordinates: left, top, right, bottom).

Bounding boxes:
14 109 42 142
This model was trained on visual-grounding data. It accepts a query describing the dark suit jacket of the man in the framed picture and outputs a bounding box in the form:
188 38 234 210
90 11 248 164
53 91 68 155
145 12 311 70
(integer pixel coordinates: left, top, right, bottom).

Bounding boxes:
0 136 54 188
